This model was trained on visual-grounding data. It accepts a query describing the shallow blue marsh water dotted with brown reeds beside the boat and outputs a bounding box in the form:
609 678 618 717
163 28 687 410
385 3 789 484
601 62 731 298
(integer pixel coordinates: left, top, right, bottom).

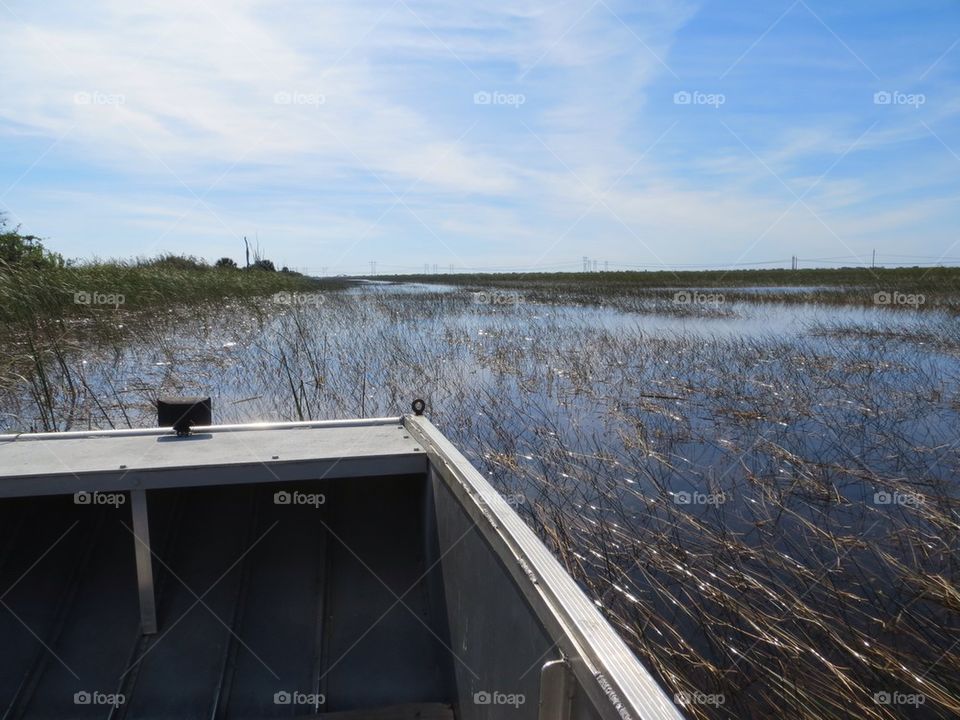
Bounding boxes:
0 284 960 718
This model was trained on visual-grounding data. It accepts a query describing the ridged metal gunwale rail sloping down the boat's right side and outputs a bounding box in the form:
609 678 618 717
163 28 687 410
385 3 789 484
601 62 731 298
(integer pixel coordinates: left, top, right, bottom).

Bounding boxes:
404 415 683 720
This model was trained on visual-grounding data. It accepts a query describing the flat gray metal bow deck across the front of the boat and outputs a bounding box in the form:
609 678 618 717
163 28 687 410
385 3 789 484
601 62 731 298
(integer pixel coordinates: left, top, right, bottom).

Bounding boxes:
0 419 426 496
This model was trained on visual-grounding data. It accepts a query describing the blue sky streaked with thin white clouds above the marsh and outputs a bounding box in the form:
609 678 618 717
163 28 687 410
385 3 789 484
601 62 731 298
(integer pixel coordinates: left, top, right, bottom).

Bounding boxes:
0 0 960 273
